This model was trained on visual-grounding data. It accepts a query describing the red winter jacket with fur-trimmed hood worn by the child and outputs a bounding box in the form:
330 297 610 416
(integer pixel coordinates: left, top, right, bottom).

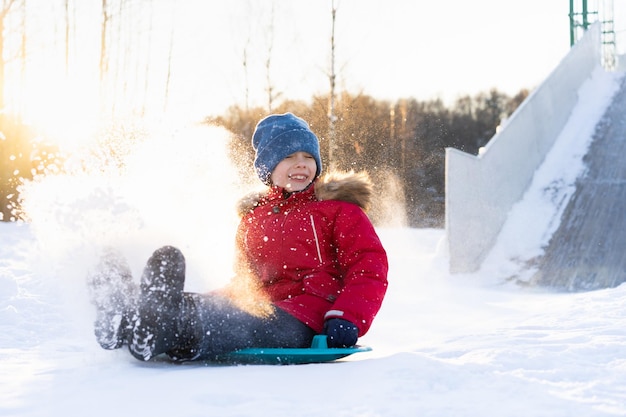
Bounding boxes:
237 174 388 336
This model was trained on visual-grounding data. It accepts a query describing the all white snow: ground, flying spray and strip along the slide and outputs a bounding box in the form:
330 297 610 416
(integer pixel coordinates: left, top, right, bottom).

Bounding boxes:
0 69 626 417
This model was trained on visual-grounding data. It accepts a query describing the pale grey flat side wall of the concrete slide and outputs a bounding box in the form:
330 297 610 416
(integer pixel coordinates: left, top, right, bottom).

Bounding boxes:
446 23 626 276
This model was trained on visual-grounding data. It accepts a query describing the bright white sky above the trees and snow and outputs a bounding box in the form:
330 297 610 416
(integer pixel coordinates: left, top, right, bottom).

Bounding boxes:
7 0 626 151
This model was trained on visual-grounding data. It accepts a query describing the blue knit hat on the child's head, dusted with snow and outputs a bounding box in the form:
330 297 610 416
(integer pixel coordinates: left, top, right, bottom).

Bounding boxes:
252 113 322 185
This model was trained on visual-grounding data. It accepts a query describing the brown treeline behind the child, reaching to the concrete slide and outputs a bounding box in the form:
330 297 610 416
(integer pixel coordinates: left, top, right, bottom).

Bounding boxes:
205 89 529 227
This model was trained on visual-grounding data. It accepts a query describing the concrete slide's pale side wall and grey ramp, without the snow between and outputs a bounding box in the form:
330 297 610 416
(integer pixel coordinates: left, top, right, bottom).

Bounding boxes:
446 24 626 291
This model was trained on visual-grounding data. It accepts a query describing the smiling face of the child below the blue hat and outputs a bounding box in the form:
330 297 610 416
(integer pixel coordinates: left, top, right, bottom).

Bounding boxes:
271 152 317 192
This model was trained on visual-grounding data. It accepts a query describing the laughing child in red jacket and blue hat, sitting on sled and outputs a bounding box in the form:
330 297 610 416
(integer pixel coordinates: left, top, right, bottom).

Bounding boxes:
88 113 388 361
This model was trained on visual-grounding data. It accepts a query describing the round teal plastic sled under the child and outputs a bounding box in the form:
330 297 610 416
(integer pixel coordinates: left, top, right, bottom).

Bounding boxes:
224 335 372 365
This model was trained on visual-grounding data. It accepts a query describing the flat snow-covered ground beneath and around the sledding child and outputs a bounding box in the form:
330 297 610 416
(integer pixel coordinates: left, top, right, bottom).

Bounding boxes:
0 224 626 417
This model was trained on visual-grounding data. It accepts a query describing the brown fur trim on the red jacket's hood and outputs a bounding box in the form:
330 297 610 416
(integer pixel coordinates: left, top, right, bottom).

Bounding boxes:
237 171 373 216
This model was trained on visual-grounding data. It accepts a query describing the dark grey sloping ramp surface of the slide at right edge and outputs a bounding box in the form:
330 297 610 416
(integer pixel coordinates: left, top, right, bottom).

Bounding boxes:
534 75 626 290
